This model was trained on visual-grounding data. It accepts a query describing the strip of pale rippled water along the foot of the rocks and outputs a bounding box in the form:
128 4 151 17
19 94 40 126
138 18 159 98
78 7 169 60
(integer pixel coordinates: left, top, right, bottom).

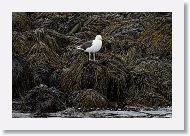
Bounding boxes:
12 107 172 118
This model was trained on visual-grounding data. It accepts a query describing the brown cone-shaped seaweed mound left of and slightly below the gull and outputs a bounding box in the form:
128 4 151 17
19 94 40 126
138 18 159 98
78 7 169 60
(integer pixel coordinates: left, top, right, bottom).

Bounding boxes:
27 42 62 85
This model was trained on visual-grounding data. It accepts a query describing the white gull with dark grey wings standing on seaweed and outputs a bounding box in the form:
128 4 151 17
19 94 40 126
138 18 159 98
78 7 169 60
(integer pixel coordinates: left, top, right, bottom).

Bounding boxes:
77 35 102 61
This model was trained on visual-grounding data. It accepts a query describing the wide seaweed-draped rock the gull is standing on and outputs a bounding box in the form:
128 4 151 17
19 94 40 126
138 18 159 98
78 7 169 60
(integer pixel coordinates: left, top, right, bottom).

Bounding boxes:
61 56 129 101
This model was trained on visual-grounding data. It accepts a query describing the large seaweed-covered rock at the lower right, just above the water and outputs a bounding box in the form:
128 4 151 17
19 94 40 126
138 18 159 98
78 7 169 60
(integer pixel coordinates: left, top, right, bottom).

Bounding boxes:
126 59 172 107
